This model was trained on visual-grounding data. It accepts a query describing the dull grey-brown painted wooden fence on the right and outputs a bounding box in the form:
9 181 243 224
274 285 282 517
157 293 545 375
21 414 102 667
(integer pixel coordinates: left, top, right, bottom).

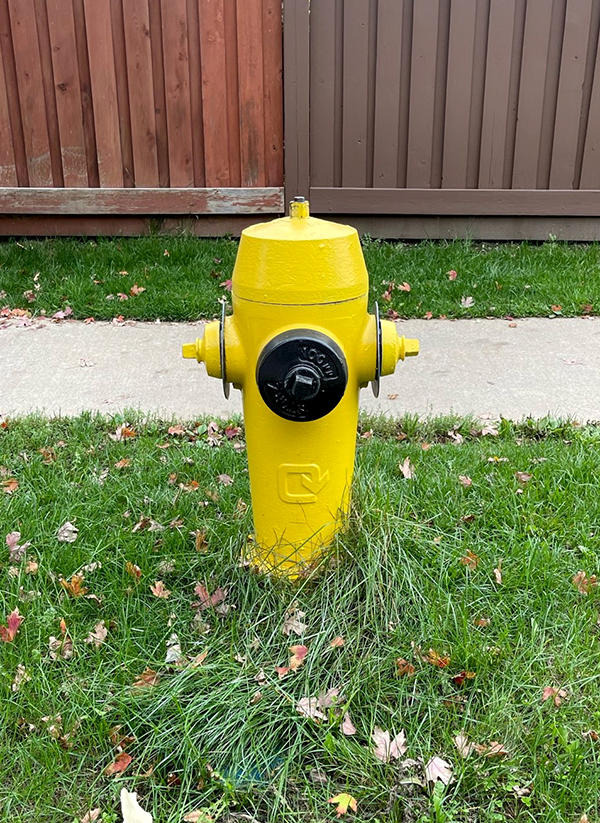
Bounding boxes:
285 0 600 238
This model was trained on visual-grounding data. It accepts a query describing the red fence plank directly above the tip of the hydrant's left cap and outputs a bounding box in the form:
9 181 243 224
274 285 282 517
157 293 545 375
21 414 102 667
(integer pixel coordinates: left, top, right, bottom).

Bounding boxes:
162 0 194 188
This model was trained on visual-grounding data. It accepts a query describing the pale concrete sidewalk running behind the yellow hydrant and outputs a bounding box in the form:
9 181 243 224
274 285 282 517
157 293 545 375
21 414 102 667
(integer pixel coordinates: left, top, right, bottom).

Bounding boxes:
0 318 600 421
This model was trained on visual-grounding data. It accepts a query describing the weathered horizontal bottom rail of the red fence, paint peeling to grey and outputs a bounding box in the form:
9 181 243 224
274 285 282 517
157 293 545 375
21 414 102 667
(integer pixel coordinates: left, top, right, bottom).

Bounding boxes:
0 186 283 215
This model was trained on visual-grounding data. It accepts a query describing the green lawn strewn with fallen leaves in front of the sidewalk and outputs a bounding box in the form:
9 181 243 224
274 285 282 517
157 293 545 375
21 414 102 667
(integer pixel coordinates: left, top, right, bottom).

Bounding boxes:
0 416 600 823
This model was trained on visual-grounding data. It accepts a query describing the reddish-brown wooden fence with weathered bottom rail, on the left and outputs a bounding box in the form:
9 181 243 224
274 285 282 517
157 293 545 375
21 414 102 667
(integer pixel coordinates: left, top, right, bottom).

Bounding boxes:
0 0 283 229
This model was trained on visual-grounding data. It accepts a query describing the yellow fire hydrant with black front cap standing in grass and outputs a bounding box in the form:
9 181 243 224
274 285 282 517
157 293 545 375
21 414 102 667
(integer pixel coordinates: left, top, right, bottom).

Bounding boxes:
183 198 419 576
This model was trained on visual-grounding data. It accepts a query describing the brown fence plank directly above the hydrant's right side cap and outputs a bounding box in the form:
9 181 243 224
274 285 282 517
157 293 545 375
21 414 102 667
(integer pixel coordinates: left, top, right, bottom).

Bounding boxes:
373 0 404 188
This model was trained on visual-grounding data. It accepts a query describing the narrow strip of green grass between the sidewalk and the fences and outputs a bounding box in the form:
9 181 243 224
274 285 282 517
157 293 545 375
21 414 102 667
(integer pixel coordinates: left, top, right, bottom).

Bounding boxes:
0 237 600 320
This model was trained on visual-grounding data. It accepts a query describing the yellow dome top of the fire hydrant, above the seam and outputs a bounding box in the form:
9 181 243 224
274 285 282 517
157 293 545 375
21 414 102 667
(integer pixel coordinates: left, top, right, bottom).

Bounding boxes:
232 216 369 305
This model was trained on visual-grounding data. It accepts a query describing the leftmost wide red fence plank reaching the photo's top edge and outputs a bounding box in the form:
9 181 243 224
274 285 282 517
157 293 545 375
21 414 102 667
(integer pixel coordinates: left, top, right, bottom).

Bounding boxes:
8 0 53 186
